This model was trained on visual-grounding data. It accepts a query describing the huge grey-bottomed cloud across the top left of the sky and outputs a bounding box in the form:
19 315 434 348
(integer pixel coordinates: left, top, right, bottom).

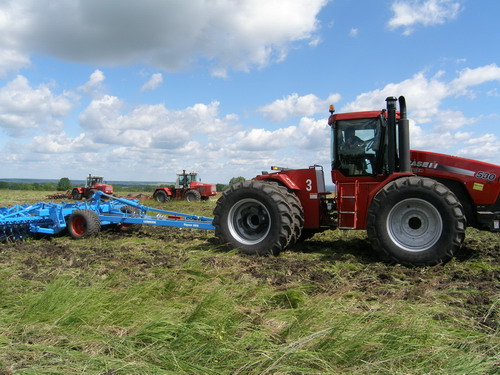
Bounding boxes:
0 0 327 76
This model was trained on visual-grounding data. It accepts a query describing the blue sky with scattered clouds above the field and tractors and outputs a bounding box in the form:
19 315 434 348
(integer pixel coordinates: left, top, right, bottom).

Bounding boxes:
0 0 500 183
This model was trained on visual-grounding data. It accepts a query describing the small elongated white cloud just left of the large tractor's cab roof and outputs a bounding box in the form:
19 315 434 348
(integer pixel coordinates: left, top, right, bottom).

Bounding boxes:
258 93 341 122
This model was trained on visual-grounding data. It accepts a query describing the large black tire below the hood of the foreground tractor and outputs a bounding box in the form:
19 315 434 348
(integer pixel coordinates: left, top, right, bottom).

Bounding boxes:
366 176 466 266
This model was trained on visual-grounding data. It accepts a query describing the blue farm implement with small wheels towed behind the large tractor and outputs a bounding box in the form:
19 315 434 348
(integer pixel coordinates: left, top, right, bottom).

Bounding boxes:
0 191 215 241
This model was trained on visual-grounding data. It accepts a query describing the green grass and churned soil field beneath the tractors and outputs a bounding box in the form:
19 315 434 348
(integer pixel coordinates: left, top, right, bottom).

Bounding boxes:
0 191 500 375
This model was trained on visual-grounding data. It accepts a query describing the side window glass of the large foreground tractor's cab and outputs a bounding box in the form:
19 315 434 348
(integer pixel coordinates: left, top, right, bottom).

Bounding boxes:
332 118 381 176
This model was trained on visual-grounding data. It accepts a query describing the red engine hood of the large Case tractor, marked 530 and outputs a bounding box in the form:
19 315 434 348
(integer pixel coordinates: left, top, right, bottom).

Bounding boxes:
410 150 500 205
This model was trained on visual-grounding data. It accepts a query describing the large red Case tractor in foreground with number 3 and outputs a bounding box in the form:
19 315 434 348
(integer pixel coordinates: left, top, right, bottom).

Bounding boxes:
213 97 500 265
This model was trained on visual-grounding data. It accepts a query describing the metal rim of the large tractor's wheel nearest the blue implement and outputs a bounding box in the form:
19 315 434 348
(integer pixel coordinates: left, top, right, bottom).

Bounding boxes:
228 198 271 245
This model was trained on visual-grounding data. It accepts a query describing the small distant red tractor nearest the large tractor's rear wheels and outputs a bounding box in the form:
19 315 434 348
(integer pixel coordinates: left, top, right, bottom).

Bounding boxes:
153 171 217 202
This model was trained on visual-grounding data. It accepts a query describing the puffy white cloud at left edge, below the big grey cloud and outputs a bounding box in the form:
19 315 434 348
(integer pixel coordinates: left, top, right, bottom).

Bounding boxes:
0 75 73 137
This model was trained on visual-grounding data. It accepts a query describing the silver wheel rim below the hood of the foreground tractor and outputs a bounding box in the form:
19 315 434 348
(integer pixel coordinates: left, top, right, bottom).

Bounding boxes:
387 198 443 252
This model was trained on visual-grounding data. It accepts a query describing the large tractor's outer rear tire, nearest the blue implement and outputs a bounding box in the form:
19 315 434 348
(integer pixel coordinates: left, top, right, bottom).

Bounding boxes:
213 181 294 255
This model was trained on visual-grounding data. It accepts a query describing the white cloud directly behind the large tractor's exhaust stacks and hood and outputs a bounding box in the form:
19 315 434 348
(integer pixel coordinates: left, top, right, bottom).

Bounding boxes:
340 64 500 163
